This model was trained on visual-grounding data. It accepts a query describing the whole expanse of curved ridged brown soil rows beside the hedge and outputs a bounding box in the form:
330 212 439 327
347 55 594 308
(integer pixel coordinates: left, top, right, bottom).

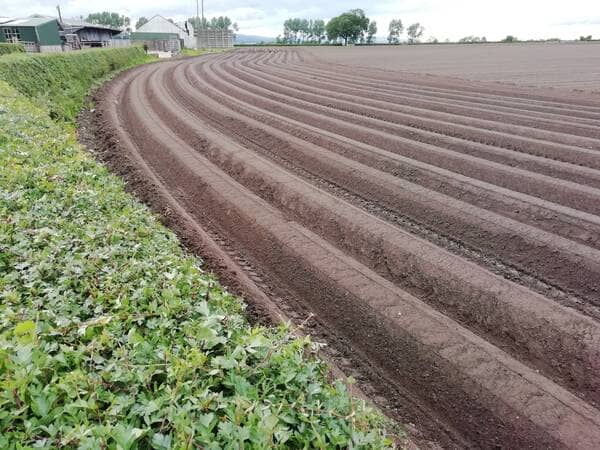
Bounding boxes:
85 50 600 448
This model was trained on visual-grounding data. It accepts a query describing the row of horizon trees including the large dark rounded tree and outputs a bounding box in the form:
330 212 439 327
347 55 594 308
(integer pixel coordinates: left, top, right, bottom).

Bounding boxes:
277 9 425 45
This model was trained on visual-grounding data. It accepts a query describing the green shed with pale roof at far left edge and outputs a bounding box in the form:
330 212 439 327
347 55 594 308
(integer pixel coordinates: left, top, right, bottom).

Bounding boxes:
0 15 63 52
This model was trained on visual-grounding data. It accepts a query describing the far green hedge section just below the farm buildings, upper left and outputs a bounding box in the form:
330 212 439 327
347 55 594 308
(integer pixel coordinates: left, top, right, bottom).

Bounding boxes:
0 47 149 120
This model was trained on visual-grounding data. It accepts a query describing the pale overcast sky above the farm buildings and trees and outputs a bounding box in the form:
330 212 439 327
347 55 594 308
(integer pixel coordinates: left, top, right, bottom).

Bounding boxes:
0 0 600 40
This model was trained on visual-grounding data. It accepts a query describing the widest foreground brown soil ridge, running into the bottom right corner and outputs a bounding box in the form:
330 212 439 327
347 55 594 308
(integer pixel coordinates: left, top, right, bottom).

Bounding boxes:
110 60 598 447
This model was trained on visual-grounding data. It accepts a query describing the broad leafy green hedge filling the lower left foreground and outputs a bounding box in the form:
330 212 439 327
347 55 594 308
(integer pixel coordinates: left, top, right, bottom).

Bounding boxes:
0 48 391 442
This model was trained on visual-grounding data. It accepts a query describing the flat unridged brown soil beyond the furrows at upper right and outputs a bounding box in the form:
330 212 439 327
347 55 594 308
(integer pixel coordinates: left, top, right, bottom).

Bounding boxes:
310 42 600 94
